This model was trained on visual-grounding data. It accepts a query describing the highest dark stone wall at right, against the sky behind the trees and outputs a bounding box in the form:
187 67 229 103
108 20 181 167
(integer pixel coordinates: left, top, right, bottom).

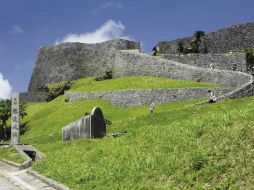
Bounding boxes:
157 23 254 54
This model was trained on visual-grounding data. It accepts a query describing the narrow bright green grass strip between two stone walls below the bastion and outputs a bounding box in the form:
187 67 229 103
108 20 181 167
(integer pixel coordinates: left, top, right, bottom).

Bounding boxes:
70 76 218 92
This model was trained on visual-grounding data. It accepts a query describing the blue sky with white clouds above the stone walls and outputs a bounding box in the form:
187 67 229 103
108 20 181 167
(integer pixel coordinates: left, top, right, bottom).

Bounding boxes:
0 0 254 98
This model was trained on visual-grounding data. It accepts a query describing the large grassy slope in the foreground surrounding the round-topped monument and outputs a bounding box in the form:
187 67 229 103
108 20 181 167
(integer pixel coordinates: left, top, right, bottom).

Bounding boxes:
17 97 254 189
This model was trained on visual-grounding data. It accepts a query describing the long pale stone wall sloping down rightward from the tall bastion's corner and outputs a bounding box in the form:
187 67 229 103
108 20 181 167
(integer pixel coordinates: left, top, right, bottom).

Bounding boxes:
114 50 252 87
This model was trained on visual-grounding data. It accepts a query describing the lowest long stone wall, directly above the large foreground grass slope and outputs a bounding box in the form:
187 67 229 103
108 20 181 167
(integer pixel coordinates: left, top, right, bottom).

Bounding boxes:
65 88 230 107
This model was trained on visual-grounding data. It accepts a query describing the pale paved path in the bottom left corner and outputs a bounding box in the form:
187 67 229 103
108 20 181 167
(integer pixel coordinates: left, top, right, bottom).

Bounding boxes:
0 161 54 190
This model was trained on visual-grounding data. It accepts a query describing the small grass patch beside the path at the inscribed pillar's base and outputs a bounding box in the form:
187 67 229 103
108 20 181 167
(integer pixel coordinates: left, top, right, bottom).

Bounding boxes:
0 147 25 163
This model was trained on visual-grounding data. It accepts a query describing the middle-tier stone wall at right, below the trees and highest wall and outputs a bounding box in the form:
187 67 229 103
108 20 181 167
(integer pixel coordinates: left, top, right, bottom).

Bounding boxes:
164 53 247 72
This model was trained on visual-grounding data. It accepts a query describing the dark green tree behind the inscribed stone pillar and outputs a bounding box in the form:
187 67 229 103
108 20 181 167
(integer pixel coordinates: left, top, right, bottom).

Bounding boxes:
0 99 27 140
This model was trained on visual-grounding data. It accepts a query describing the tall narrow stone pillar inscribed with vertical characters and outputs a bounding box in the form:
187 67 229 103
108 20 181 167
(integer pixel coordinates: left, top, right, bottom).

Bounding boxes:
11 92 19 145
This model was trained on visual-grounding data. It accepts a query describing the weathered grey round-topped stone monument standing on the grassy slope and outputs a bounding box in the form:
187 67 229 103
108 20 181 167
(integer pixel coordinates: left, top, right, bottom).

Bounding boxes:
62 107 107 141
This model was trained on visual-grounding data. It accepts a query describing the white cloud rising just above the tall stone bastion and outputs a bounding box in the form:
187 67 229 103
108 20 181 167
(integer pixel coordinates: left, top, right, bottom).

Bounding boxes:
56 20 133 44
